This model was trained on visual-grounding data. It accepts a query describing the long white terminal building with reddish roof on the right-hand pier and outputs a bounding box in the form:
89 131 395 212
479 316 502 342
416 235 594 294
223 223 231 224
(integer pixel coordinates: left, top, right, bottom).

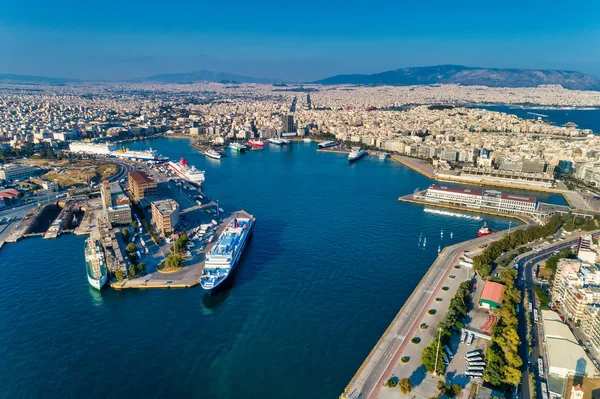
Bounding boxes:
425 184 538 213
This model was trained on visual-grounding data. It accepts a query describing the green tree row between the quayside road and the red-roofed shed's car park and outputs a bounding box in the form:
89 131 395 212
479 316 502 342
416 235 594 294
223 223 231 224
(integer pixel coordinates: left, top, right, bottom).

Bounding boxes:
421 281 472 373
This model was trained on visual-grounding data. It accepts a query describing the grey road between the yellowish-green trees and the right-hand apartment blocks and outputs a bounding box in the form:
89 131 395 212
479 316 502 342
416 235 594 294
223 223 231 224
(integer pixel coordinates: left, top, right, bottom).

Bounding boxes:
514 231 600 398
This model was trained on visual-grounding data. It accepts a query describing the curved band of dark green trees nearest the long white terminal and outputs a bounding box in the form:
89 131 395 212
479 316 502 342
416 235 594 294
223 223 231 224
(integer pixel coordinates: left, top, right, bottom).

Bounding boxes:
473 215 562 277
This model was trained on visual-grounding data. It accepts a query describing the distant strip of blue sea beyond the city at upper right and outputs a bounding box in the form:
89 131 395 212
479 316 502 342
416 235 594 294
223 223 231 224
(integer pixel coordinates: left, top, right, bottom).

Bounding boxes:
477 105 600 134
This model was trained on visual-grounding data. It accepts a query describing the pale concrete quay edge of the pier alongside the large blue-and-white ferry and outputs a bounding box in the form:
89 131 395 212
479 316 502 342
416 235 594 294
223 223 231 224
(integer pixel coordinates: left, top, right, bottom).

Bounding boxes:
110 210 252 290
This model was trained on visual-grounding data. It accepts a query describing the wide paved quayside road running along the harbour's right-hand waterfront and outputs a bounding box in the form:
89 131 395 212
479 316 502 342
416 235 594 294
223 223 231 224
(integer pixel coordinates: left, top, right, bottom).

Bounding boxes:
342 225 528 399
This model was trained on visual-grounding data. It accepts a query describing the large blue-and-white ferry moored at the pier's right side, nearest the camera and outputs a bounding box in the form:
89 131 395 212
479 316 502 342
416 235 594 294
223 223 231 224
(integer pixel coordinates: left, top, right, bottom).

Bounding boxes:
200 215 255 295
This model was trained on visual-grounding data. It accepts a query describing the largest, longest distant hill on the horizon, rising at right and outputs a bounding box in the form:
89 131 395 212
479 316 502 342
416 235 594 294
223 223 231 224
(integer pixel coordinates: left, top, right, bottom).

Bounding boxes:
314 65 600 90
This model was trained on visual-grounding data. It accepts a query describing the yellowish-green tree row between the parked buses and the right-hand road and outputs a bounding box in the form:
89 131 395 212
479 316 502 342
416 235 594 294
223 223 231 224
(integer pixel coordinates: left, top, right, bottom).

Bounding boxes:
483 269 523 387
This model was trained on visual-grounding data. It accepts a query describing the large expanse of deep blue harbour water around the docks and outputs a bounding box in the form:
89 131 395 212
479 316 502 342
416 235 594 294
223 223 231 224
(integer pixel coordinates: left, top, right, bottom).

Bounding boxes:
0 139 540 399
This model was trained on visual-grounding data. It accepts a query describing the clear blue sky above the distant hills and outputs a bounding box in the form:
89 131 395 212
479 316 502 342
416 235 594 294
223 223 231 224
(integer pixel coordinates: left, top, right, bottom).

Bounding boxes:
0 0 600 81
